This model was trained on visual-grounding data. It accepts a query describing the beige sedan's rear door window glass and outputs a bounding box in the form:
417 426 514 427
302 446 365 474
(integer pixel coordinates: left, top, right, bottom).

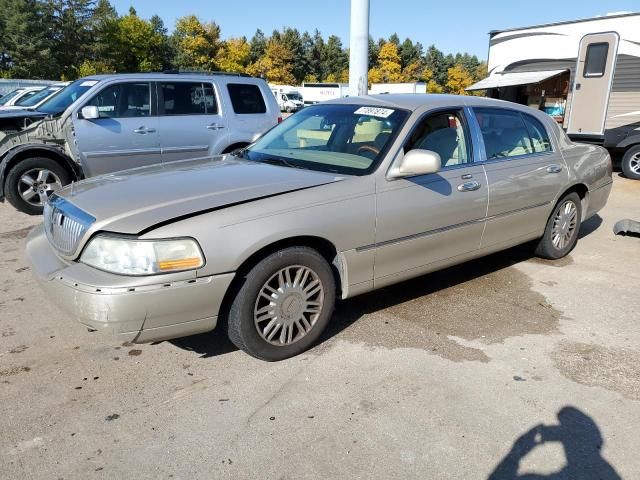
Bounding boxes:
474 109 536 160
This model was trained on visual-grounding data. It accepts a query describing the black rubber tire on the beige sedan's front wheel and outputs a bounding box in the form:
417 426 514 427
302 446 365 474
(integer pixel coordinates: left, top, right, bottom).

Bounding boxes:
226 247 336 362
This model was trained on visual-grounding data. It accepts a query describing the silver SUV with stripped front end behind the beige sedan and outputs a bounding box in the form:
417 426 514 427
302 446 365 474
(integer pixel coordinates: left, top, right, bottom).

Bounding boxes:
0 73 280 215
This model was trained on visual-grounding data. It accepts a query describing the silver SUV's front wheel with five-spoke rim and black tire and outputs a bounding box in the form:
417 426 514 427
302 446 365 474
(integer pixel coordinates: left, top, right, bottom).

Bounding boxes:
5 157 71 215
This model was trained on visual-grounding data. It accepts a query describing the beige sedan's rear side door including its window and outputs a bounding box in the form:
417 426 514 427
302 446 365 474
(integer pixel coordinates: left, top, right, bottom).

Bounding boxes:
474 108 568 247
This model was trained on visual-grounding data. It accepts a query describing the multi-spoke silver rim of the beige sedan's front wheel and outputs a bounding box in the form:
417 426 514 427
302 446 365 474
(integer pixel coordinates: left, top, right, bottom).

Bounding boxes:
253 265 324 346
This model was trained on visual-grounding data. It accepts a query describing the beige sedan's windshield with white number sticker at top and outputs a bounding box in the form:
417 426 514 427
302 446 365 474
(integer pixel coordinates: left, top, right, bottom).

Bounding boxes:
242 104 408 175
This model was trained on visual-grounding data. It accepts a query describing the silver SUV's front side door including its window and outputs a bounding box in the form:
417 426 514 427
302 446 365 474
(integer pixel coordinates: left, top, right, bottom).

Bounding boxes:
73 82 161 177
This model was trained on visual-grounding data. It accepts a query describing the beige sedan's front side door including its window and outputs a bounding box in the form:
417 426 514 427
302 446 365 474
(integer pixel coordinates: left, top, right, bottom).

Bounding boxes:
374 110 488 287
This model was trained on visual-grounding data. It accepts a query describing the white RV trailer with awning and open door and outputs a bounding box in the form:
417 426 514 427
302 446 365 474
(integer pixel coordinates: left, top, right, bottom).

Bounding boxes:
468 13 640 179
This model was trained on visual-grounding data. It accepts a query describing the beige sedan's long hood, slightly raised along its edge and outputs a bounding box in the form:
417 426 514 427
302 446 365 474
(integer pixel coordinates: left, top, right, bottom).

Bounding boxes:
58 155 342 234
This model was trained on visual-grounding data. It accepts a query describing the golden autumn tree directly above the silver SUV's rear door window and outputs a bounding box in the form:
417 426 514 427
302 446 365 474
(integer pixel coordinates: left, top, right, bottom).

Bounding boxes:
173 15 220 70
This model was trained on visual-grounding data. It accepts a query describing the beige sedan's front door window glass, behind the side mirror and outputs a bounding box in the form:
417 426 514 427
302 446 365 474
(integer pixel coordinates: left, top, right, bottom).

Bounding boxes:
405 112 471 168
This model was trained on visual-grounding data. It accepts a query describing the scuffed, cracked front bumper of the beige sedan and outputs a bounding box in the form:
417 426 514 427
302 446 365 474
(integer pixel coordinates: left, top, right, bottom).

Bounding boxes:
26 226 234 343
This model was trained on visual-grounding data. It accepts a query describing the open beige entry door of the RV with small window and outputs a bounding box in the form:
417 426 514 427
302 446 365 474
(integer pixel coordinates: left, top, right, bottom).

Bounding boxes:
567 32 619 137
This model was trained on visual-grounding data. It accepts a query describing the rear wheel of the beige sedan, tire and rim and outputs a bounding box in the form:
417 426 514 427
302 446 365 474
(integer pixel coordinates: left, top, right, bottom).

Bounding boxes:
535 192 582 260
